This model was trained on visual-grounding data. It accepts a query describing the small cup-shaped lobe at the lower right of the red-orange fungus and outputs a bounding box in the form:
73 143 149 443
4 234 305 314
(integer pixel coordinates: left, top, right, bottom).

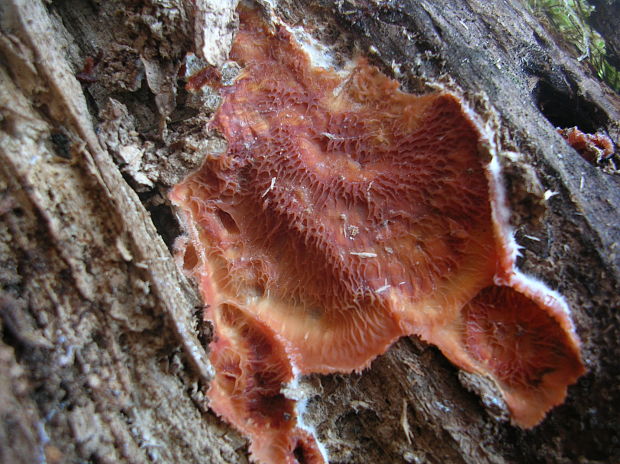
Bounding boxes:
463 286 583 425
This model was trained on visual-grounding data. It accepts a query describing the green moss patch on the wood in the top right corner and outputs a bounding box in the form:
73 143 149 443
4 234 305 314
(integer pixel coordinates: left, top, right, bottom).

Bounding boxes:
526 0 620 93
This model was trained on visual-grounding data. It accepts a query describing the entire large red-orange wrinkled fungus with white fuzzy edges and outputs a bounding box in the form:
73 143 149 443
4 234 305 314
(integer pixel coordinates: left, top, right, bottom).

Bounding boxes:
171 9 584 463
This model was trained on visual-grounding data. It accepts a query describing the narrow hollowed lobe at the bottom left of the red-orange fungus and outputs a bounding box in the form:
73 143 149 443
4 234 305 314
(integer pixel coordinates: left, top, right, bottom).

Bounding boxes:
208 303 323 464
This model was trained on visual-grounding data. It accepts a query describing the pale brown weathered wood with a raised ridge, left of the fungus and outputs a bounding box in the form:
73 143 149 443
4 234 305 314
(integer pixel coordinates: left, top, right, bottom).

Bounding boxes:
0 2 243 463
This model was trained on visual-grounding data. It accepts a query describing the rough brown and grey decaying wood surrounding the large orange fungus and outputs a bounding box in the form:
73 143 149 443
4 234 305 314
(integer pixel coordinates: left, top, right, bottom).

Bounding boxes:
0 0 620 463
